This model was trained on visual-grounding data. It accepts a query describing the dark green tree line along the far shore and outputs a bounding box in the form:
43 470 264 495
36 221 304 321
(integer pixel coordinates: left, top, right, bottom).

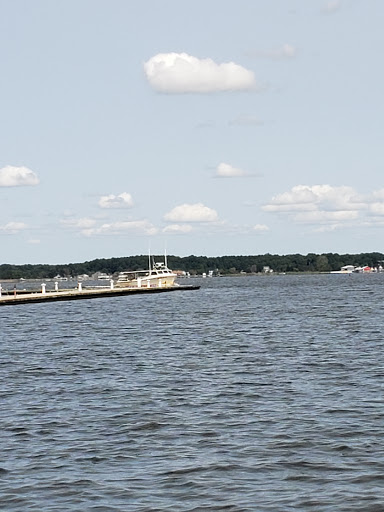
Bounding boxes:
0 252 384 279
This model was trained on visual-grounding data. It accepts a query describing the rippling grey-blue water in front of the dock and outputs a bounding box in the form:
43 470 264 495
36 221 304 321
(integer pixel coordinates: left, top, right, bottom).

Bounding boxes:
0 274 384 512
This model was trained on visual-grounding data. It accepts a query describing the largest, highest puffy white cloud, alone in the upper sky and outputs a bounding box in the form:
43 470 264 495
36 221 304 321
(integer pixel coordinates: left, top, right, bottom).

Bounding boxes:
144 53 257 93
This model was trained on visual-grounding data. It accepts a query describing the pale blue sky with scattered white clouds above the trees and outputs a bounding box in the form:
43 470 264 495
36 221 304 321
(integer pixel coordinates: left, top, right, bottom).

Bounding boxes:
0 0 384 264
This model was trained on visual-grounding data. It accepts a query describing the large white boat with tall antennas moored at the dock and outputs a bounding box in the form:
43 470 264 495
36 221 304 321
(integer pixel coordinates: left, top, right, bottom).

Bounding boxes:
115 257 178 288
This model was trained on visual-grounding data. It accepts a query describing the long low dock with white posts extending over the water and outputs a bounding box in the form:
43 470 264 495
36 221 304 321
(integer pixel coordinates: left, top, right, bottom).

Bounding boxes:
0 285 200 306
